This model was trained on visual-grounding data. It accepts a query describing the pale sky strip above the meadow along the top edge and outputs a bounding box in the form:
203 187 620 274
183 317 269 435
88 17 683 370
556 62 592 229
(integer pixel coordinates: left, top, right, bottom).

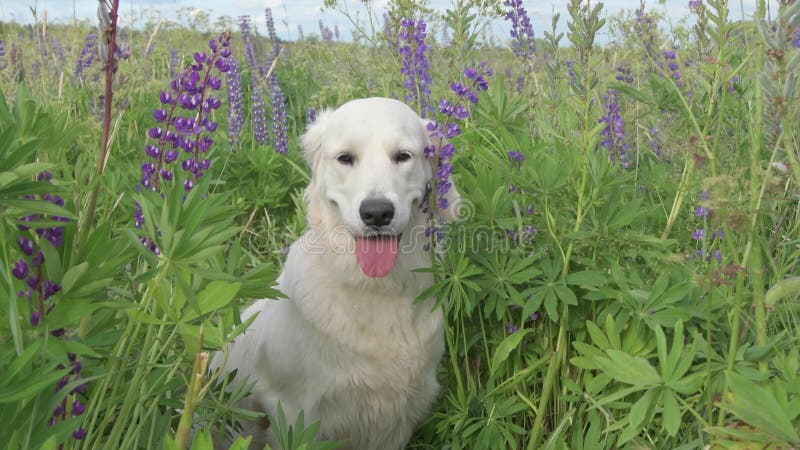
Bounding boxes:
0 0 777 42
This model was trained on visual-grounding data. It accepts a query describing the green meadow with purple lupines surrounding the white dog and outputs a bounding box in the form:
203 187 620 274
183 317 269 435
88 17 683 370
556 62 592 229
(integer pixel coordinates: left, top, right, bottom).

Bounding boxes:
0 0 800 450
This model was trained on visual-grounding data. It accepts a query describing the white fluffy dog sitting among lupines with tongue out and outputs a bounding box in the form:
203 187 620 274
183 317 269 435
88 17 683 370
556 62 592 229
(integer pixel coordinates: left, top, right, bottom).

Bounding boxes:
217 98 458 450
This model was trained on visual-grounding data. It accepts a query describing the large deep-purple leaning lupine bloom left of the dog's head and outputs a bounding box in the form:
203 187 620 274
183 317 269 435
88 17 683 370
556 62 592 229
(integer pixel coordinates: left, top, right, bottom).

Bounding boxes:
140 32 230 191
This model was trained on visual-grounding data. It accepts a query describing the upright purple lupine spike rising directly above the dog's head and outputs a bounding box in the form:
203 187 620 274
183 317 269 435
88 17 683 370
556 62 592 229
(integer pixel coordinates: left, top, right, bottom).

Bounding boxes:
397 19 433 117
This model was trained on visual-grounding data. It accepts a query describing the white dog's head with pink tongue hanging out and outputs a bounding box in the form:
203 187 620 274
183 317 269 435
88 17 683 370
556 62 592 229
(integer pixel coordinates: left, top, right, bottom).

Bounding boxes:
302 98 458 276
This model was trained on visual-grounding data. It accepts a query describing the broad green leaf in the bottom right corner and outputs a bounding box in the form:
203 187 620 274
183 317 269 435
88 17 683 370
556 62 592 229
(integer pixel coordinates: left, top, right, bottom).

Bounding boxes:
724 371 800 444
